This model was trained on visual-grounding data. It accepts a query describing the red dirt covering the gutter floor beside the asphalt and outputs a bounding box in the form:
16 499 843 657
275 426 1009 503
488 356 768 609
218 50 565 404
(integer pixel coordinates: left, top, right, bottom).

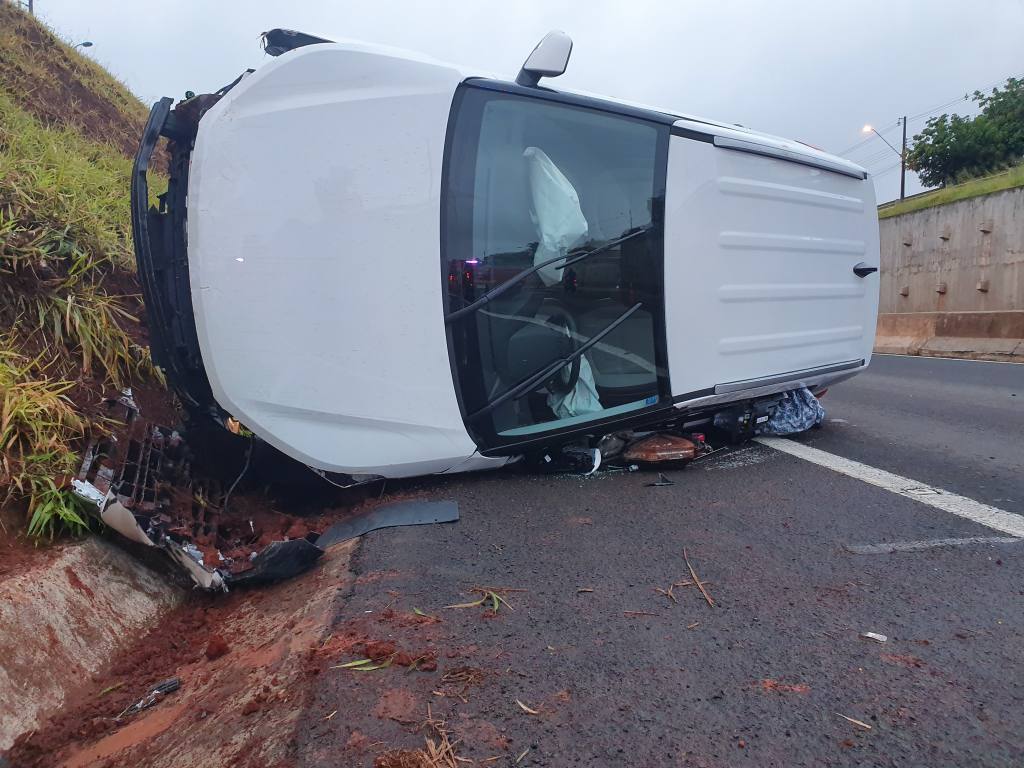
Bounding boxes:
7 544 353 768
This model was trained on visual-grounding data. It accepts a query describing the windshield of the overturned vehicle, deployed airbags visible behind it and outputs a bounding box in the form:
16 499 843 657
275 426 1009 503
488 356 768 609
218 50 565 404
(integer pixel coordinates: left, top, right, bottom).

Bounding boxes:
442 86 668 446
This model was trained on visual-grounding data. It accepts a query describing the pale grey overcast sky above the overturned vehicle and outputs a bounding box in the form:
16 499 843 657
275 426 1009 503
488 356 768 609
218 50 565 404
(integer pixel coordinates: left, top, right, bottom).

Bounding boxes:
36 0 1024 202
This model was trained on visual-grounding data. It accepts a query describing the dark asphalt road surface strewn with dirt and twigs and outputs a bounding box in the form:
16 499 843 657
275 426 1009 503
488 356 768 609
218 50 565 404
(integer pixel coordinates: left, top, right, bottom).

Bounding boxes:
297 357 1024 768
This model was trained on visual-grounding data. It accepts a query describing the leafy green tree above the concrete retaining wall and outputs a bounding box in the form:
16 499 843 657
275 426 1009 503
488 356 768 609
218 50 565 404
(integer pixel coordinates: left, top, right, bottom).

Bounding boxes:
907 78 1024 186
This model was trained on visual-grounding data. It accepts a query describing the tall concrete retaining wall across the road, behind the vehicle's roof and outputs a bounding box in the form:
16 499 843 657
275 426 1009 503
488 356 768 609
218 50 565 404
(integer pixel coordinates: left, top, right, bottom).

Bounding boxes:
876 187 1024 360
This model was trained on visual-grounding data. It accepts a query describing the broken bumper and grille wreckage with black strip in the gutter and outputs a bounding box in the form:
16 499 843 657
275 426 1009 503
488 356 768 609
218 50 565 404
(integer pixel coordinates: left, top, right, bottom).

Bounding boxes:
72 399 459 592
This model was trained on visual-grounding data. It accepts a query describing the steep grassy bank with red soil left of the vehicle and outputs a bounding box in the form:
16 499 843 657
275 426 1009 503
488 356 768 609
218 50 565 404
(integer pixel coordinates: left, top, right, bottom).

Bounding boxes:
0 0 166 535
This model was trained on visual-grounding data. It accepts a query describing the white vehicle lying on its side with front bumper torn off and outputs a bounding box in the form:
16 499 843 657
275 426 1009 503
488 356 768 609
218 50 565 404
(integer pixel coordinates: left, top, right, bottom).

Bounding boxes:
132 30 879 477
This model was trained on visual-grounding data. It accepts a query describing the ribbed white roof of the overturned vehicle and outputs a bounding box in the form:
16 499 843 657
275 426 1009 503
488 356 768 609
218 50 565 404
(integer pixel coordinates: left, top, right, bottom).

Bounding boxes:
665 121 879 402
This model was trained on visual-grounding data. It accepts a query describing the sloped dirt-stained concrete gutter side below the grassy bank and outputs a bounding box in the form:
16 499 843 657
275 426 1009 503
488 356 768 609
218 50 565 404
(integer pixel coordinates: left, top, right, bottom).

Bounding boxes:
0 537 183 751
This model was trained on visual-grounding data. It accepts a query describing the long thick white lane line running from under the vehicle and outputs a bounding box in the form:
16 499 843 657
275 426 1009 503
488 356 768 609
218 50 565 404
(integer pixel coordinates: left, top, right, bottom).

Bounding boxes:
754 437 1024 538
